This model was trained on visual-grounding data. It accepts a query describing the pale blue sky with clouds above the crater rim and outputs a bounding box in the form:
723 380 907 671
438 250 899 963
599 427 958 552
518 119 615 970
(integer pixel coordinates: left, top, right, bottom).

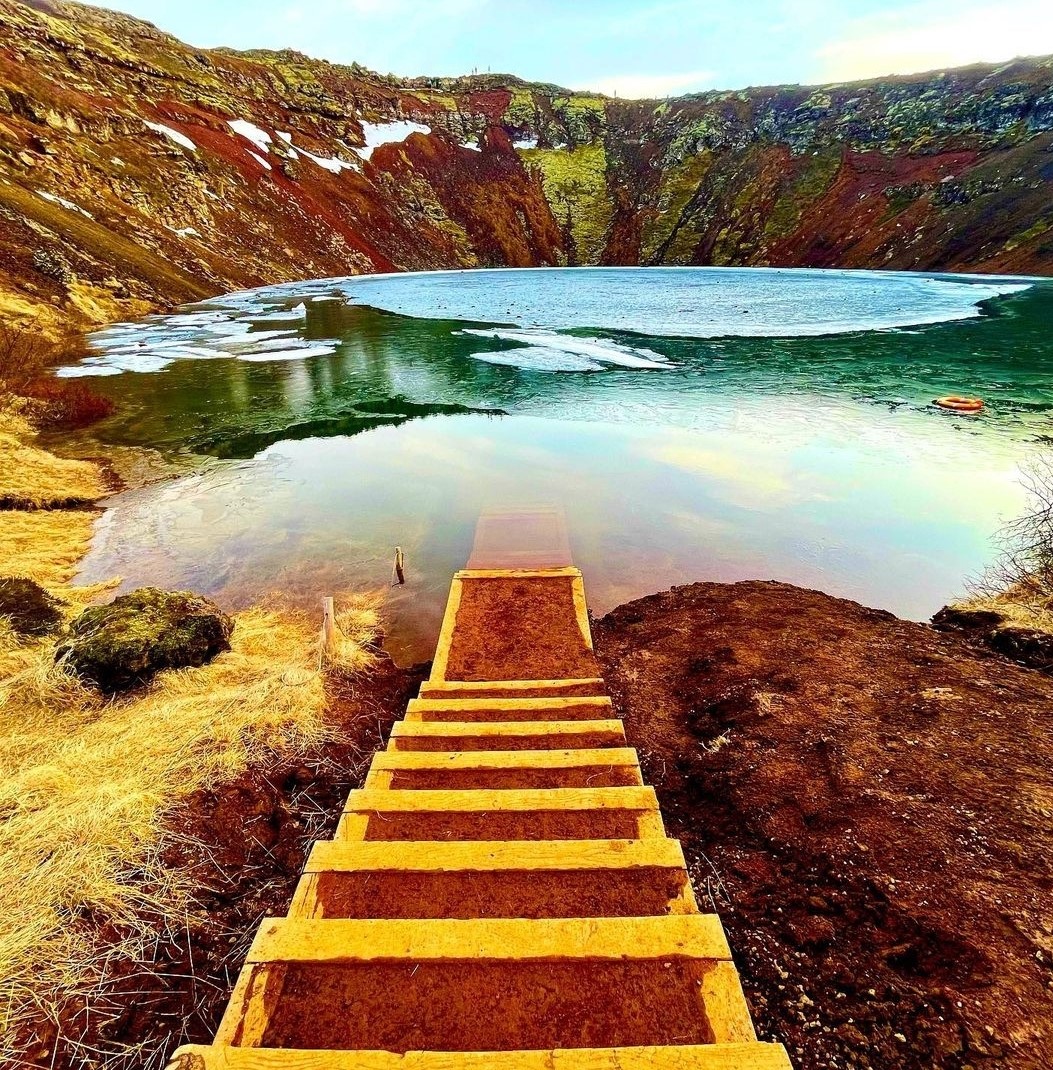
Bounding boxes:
90 0 1053 96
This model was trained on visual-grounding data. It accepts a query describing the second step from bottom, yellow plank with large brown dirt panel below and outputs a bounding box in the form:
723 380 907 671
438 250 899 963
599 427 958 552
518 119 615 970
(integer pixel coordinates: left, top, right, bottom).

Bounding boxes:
217 915 756 1052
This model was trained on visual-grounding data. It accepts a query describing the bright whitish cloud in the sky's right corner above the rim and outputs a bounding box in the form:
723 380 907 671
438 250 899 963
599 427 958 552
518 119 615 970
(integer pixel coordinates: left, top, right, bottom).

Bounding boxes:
817 0 1053 81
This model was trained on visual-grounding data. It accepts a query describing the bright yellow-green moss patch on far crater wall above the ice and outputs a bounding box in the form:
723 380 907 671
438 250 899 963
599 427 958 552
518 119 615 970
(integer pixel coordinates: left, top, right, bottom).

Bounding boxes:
522 141 614 264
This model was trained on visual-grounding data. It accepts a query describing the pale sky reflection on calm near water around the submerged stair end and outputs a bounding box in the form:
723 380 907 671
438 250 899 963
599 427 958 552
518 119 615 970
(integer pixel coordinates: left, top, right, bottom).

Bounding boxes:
85 404 1020 658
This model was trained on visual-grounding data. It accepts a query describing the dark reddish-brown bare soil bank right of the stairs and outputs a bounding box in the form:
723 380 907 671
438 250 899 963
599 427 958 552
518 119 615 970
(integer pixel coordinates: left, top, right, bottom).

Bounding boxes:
596 582 1053 1070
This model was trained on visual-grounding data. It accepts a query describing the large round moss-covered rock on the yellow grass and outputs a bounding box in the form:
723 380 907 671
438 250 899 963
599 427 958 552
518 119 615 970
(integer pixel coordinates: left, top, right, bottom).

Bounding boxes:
56 587 234 692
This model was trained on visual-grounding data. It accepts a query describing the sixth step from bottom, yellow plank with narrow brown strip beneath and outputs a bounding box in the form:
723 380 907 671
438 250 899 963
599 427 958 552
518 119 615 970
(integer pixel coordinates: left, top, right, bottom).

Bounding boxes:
388 719 625 751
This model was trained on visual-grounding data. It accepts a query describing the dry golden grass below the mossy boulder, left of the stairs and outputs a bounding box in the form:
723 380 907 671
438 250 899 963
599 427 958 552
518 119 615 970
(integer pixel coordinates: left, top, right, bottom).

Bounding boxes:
0 610 375 1061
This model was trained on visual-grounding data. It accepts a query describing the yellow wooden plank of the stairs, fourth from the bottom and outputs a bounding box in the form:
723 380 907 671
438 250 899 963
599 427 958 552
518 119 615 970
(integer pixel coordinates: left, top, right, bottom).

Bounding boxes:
344 788 658 813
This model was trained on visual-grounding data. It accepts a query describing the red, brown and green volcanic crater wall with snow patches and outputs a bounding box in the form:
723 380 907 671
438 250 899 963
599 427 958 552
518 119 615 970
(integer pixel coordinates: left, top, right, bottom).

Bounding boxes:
0 0 1053 332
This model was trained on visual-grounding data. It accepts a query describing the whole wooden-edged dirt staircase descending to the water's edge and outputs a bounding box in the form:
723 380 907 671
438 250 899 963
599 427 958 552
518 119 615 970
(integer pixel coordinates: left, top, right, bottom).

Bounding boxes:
173 522 790 1070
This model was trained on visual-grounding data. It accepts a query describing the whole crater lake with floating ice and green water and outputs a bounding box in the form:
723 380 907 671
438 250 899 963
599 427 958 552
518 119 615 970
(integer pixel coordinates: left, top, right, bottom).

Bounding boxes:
62 269 1053 659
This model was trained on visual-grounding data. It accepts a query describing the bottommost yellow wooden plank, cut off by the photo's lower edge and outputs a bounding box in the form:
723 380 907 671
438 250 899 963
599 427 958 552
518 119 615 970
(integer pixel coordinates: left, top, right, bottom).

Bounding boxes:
169 1043 791 1070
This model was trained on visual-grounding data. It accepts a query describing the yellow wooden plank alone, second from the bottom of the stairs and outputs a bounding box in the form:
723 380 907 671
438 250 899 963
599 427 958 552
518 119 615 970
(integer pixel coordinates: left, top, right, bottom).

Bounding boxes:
245 914 731 964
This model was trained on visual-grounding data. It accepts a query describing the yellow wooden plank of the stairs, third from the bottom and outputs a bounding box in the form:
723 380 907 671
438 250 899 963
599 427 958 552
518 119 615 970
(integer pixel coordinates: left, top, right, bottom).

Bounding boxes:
304 839 686 873
